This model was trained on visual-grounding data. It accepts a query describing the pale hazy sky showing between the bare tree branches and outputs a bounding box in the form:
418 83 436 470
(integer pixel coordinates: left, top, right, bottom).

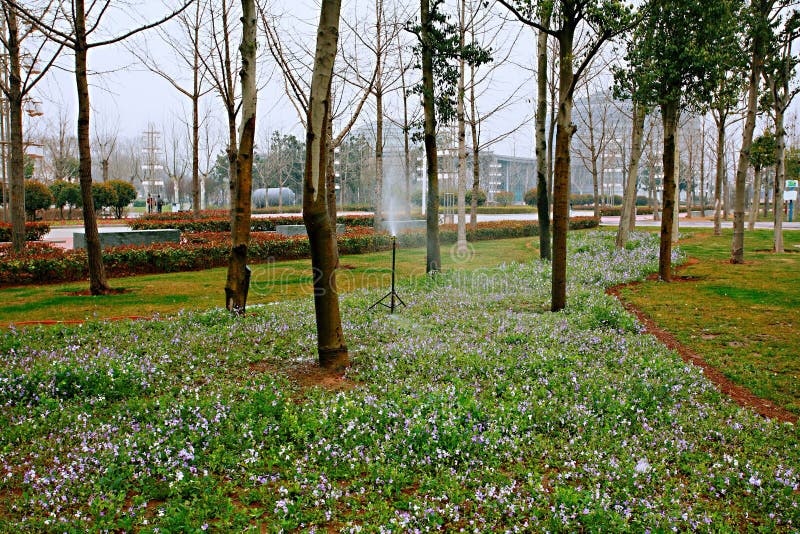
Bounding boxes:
29 0 552 160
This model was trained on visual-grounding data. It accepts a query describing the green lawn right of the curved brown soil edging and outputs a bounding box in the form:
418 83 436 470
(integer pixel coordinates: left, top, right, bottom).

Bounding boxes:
622 229 800 414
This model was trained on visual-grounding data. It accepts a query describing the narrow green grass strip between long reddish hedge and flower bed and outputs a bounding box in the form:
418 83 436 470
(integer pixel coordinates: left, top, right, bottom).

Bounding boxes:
0 238 538 326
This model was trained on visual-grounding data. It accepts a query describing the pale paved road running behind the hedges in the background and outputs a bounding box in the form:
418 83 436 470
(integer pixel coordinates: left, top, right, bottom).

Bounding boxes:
44 211 800 249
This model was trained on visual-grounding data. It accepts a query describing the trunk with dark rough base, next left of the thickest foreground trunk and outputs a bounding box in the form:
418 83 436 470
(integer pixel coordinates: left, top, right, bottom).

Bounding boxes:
225 0 257 314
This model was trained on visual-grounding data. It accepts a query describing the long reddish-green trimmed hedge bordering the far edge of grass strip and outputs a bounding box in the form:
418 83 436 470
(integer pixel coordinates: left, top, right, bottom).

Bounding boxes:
0 217 599 286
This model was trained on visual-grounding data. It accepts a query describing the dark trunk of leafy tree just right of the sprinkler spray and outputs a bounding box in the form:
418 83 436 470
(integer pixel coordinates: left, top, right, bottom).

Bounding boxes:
420 0 442 273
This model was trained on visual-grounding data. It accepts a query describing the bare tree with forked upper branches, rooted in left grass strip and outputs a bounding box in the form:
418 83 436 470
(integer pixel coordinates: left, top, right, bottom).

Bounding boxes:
9 0 192 295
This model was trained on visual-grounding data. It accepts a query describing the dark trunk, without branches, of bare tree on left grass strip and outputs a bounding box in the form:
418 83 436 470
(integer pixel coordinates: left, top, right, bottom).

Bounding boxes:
74 0 111 295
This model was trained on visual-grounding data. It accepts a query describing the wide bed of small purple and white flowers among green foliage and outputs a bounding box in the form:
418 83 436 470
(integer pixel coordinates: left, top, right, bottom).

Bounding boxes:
0 232 800 533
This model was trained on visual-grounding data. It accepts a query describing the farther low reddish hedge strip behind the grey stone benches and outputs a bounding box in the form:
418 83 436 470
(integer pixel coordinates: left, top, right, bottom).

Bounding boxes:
130 213 374 234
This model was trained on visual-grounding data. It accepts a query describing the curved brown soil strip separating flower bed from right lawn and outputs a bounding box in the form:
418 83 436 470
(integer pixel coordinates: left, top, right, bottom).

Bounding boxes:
606 282 797 423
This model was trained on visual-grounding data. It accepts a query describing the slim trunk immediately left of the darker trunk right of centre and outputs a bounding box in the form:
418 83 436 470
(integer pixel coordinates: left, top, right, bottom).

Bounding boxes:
536 12 552 261
